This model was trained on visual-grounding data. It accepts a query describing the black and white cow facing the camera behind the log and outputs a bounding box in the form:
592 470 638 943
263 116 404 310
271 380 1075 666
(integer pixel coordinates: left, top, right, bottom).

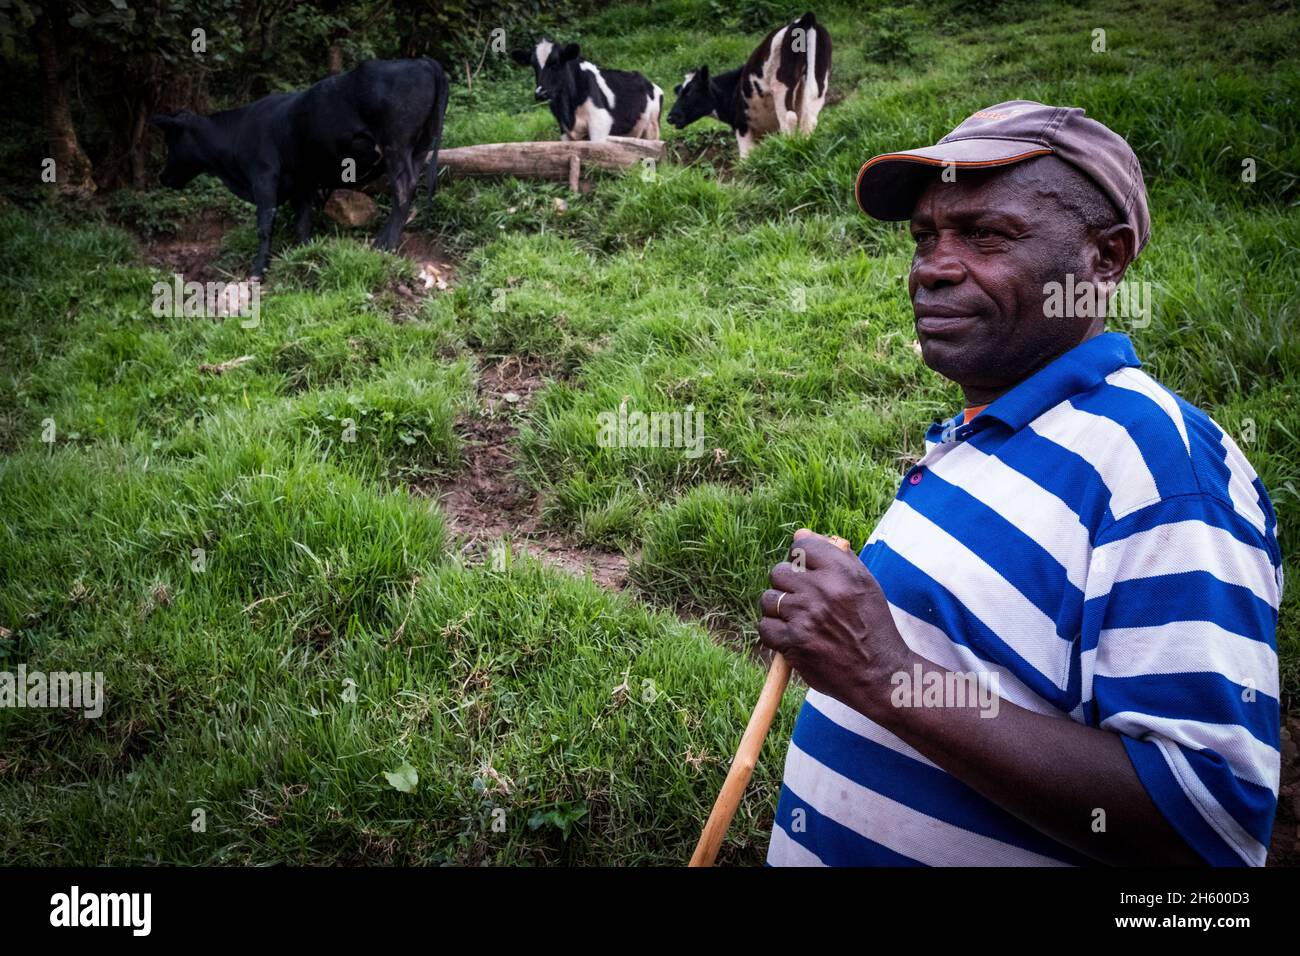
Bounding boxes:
511 39 663 143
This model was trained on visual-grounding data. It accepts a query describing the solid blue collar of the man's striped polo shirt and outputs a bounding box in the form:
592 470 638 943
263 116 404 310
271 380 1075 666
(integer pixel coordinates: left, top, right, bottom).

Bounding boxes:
971 332 1141 431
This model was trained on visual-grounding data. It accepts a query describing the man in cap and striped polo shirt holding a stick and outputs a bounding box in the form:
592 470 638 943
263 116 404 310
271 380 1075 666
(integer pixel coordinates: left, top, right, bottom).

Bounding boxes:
759 100 1282 865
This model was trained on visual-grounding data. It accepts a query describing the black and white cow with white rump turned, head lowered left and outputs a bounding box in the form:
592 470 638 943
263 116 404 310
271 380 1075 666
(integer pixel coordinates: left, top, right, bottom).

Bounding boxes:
668 13 831 157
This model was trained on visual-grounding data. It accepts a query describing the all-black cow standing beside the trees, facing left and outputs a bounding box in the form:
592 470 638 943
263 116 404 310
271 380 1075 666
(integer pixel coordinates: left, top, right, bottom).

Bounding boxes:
150 59 450 278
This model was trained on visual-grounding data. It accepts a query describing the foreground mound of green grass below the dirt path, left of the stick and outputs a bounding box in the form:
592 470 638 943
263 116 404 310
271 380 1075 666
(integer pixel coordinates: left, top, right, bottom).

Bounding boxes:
0 437 794 864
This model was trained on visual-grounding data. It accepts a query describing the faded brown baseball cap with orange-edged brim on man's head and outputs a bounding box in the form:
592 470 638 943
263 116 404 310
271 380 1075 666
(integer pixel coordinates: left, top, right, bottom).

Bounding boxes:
854 100 1151 251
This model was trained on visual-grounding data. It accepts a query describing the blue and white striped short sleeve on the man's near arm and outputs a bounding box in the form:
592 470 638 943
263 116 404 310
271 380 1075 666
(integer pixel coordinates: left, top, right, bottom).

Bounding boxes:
1080 496 1282 866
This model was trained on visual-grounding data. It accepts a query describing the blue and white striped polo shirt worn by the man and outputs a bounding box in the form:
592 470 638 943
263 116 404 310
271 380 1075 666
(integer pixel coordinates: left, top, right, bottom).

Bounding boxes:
767 333 1282 866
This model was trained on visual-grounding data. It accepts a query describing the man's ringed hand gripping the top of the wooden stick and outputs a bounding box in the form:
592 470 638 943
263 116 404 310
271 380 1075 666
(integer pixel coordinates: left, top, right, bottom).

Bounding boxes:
758 528 910 702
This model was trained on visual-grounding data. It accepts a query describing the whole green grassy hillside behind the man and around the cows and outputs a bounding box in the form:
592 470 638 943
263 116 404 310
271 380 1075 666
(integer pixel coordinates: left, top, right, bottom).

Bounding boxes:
0 0 1300 864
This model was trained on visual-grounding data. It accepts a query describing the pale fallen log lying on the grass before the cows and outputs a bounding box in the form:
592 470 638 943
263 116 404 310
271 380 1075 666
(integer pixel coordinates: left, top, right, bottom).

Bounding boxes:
438 137 664 193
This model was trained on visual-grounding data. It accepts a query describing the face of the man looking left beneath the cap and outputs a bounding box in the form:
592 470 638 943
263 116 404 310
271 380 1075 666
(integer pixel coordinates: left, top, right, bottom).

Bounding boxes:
907 157 1102 403
